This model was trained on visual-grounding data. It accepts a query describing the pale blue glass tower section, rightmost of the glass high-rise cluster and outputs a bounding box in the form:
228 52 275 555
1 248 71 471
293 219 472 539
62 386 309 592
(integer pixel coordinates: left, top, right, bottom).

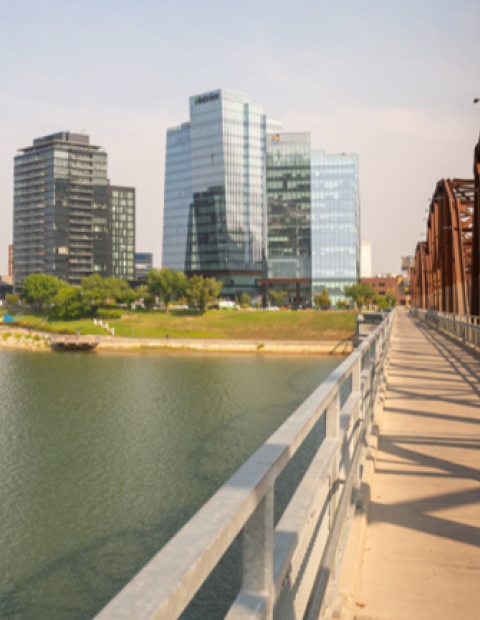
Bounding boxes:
311 151 360 304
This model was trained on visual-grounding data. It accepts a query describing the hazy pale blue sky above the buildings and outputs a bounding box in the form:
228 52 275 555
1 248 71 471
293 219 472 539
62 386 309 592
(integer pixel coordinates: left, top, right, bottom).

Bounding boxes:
0 0 480 274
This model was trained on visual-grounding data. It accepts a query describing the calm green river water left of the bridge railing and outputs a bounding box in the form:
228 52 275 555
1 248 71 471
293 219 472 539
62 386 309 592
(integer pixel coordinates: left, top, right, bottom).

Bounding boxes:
0 350 341 620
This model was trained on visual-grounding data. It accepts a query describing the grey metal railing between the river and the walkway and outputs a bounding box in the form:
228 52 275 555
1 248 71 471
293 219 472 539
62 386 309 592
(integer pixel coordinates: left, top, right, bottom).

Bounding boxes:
96 312 395 620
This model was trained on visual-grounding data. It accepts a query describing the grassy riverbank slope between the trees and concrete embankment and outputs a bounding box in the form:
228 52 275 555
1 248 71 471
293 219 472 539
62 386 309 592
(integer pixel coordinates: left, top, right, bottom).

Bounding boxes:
0 309 355 341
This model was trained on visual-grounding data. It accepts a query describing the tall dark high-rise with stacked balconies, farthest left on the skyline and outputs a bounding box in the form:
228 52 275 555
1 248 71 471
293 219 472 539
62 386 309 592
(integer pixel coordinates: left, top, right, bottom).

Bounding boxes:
13 131 134 290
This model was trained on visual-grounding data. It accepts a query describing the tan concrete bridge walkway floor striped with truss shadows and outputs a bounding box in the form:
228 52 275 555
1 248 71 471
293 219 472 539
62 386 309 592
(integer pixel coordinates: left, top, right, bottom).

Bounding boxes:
355 311 480 620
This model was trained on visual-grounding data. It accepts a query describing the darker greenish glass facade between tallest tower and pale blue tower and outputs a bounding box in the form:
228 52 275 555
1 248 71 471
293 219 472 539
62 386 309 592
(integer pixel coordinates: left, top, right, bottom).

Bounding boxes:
265 133 311 279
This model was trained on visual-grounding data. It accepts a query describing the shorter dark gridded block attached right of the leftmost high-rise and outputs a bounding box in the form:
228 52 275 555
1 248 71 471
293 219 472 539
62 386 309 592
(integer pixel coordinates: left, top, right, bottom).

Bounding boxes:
109 185 135 281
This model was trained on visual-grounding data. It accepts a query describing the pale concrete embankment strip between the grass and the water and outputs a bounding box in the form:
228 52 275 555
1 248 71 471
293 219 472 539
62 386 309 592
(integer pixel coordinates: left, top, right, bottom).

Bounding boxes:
96 337 353 355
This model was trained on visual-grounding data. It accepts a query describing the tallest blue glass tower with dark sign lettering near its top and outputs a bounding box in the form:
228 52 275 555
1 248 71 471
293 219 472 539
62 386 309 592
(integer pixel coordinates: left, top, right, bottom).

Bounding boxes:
162 89 281 295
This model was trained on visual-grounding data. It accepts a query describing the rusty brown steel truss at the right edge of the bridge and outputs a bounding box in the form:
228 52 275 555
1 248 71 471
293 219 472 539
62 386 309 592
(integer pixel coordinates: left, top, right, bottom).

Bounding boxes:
411 133 480 316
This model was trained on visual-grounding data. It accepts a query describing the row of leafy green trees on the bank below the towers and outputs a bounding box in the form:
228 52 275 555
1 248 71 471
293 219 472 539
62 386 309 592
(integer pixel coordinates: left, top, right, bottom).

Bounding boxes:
7 268 222 319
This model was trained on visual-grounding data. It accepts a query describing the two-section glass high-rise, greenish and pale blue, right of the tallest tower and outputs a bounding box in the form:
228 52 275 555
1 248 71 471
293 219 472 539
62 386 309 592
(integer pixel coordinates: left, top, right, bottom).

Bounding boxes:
260 140 360 305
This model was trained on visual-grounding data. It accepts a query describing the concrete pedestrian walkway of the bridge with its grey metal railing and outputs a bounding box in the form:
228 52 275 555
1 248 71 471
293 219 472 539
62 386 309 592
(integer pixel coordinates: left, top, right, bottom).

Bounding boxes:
97 310 480 620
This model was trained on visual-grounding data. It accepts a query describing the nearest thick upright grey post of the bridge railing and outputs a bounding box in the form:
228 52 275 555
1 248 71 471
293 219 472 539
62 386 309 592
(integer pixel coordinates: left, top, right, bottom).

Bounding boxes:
242 487 274 620
